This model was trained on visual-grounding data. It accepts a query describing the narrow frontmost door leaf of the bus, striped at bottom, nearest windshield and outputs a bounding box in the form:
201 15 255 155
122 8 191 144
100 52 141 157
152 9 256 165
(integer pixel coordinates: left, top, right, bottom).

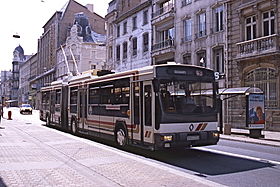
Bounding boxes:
141 81 155 143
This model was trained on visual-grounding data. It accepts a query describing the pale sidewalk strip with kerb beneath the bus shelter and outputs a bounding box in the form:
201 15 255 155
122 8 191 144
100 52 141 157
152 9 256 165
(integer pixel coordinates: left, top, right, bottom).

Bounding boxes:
220 128 280 147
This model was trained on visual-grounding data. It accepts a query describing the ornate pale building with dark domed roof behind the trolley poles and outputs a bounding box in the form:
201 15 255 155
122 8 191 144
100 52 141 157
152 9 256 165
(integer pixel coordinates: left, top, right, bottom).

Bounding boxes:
56 13 106 79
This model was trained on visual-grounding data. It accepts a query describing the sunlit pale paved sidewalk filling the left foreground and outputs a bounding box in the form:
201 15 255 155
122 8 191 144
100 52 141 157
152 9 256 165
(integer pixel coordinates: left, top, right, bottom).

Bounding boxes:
0 109 222 187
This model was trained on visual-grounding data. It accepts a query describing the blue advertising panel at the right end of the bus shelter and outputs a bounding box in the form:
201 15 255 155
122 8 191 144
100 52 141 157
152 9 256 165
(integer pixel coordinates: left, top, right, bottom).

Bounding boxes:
247 94 265 129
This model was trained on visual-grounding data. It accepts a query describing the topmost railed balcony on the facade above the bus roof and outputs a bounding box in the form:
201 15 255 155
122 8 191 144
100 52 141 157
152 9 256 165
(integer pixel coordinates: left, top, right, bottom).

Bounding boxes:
152 4 174 24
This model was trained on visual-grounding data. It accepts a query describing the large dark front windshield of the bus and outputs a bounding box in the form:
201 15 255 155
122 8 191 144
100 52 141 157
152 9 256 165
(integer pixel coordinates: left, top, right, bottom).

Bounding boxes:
159 80 216 121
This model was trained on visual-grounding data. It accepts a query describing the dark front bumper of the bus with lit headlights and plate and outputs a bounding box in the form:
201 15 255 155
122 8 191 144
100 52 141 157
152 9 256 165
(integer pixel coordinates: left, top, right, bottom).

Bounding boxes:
155 131 220 150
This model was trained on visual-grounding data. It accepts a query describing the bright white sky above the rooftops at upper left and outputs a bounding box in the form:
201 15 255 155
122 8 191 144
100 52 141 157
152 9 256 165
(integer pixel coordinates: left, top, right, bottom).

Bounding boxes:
0 0 111 70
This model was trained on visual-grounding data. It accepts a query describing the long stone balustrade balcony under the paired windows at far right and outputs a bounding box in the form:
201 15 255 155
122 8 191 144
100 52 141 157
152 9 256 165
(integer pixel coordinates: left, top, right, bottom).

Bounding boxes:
236 34 279 58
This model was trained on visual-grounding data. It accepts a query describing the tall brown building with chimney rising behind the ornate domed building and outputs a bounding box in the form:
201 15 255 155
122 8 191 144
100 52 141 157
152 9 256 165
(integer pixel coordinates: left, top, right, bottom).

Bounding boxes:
36 0 105 88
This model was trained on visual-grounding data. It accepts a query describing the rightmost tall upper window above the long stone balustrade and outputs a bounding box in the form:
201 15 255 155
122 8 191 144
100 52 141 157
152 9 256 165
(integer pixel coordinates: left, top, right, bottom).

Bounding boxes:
263 11 275 36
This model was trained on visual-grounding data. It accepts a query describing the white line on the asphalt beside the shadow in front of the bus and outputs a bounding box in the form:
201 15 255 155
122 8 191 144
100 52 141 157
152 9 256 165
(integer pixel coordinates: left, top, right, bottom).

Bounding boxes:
193 147 280 165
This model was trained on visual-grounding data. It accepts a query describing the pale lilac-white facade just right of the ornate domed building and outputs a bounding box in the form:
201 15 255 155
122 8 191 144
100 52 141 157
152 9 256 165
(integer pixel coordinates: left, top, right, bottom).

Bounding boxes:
106 0 152 71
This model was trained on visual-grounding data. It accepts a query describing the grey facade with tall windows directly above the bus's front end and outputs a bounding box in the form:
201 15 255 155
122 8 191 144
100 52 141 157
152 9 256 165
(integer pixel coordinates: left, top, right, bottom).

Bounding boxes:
174 0 228 88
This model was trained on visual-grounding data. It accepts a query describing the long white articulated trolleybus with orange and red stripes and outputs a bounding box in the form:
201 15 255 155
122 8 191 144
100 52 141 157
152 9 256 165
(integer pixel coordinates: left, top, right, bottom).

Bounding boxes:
40 64 219 150
